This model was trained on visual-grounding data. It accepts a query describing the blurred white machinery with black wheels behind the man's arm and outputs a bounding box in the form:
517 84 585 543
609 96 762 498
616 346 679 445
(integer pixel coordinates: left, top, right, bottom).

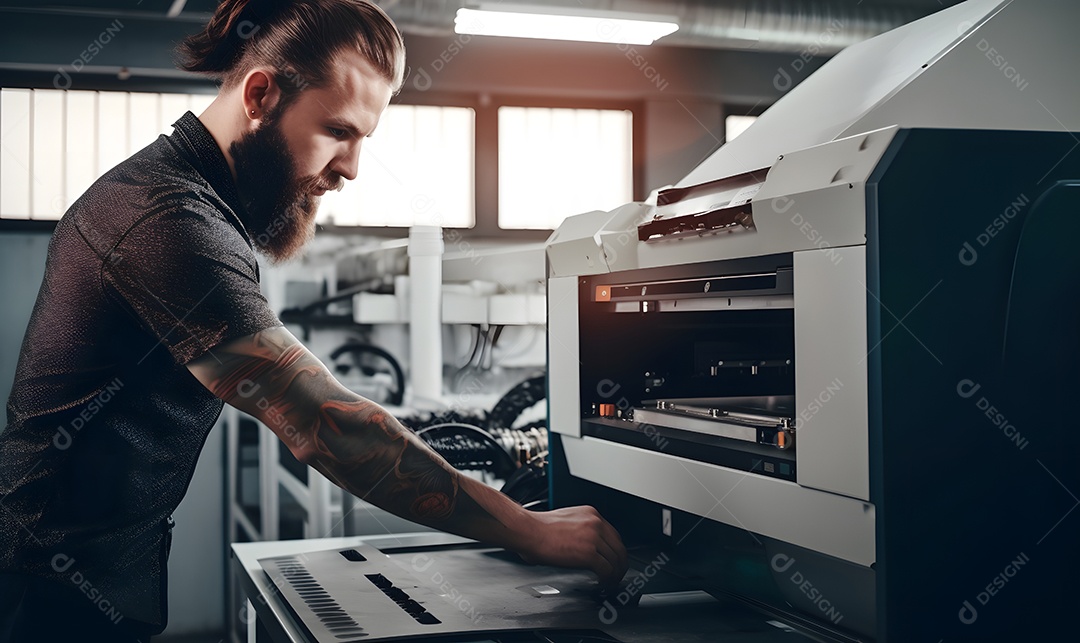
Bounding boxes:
259 228 549 536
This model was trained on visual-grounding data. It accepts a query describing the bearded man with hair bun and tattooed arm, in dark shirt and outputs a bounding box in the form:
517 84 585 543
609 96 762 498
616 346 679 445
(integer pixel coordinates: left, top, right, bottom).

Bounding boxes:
0 0 626 641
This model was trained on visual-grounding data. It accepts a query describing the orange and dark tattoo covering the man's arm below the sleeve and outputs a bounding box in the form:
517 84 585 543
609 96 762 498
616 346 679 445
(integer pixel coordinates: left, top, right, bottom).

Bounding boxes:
192 327 503 536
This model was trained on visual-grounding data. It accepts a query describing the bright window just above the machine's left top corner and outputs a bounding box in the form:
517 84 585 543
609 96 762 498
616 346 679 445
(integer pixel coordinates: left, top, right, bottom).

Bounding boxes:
499 107 634 229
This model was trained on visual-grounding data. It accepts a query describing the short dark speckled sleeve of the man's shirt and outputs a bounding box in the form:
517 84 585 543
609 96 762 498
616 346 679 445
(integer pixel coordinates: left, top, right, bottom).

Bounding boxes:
102 203 281 364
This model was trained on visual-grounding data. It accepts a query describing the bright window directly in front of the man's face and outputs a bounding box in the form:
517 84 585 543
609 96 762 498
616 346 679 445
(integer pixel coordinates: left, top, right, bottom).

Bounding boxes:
318 105 475 228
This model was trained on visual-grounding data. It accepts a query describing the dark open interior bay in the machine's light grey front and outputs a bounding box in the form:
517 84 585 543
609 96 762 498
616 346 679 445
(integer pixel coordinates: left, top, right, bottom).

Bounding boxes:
579 254 797 482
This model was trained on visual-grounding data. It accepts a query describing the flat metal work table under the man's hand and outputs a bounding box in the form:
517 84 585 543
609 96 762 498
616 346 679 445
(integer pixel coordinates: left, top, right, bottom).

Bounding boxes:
232 533 808 643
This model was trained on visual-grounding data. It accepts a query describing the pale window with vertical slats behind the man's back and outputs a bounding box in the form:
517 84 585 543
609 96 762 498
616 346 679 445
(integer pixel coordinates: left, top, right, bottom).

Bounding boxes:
0 89 214 219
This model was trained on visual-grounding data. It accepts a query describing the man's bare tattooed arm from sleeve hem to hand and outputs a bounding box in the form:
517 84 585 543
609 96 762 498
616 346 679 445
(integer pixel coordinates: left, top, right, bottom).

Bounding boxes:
188 326 626 584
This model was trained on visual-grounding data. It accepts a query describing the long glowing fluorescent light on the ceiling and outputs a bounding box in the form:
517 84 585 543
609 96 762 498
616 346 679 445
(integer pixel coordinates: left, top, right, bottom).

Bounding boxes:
454 3 678 44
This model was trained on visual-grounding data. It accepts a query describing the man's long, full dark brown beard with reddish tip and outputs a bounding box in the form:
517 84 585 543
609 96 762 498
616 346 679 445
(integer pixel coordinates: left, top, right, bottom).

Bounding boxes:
229 110 341 263
